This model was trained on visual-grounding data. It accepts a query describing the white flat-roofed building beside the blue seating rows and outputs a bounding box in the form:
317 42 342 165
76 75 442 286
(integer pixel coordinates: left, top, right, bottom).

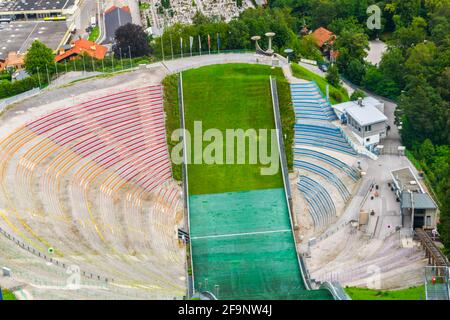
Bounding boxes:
333 97 388 150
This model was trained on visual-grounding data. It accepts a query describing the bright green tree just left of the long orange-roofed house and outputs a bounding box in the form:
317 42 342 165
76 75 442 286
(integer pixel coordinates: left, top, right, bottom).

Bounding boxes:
25 40 55 74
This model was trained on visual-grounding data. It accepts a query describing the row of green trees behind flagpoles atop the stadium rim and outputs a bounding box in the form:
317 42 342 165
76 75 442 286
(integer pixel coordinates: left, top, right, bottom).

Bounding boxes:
152 7 306 58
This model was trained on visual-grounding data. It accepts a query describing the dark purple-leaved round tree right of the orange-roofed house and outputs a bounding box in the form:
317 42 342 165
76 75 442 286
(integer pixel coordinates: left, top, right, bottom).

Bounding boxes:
113 23 151 57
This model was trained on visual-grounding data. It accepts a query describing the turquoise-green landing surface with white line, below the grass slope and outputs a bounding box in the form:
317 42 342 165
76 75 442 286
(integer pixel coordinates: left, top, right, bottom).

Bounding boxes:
189 188 329 299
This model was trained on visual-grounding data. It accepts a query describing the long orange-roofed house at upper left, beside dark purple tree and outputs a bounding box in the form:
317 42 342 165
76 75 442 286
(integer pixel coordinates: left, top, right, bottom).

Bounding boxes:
55 39 108 62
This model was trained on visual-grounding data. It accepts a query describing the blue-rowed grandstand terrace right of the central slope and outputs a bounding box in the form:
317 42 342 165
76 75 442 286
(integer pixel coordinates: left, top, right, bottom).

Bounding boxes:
291 82 360 233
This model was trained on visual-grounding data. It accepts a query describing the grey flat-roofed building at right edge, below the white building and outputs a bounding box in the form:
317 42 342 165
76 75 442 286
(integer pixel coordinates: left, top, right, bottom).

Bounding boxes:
391 167 438 229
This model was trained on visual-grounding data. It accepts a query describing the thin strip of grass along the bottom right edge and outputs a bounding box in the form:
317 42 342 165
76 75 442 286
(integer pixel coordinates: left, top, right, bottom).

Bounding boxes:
345 286 425 300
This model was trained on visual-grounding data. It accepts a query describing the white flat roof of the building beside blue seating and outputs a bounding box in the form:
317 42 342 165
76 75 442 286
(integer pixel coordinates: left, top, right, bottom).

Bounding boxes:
333 97 388 126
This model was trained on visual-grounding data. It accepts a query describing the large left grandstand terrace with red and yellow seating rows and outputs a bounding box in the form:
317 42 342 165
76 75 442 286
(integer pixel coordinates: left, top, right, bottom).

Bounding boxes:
0 85 185 299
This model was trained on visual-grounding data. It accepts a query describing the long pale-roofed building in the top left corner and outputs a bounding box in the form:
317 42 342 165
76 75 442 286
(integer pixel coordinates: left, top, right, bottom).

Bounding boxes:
0 0 79 20
